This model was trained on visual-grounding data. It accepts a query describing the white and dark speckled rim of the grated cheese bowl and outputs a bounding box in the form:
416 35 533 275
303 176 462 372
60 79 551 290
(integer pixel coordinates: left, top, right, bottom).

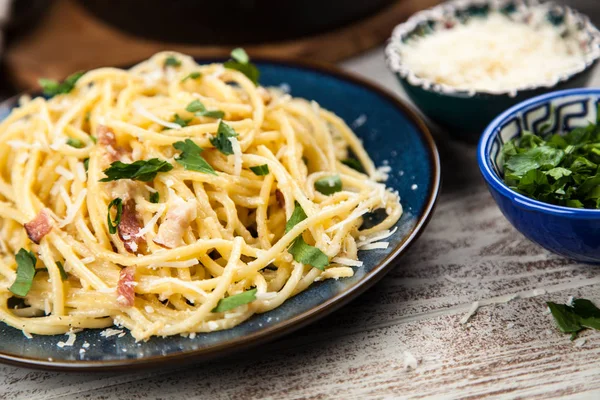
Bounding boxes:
385 0 600 97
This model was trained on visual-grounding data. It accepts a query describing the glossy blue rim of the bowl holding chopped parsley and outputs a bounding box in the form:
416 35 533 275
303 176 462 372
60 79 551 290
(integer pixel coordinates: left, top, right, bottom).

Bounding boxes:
477 89 600 219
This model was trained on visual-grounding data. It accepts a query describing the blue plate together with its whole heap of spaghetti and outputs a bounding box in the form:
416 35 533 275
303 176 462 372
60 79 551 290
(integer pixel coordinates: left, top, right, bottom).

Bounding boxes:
0 49 440 369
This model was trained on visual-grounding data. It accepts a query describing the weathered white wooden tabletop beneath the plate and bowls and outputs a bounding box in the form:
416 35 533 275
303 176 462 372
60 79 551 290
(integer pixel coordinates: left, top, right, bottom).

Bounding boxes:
0 49 600 400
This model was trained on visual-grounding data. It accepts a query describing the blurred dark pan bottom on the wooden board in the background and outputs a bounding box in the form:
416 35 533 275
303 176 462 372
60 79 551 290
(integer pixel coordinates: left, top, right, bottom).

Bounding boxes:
79 0 394 45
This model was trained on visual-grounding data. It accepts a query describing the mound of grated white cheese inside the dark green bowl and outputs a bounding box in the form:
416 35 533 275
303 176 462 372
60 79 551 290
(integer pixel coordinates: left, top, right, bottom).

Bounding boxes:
398 8 585 92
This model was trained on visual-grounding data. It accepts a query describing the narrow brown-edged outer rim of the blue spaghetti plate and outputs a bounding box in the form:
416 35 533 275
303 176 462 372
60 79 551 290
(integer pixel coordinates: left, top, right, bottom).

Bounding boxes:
0 56 441 372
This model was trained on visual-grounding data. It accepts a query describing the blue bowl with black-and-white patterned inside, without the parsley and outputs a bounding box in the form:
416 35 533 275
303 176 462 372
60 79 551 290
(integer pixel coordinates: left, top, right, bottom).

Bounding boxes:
477 89 600 263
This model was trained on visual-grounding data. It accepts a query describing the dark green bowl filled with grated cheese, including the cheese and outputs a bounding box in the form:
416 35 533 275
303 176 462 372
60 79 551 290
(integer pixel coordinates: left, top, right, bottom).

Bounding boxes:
385 0 600 142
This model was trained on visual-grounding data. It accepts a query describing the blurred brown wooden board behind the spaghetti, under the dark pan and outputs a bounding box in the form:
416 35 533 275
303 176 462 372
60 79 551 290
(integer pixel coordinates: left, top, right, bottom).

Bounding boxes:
5 0 441 88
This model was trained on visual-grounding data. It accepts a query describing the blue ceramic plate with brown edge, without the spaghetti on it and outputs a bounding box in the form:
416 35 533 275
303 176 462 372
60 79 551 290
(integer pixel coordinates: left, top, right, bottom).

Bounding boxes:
0 57 440 370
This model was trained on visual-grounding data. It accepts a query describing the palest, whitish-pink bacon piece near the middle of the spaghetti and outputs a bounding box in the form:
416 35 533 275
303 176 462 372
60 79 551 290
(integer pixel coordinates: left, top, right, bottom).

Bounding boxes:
154 197 196 249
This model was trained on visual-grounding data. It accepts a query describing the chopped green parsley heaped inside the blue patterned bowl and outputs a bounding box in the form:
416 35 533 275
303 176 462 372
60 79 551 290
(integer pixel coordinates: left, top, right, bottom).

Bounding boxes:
502 109 600 209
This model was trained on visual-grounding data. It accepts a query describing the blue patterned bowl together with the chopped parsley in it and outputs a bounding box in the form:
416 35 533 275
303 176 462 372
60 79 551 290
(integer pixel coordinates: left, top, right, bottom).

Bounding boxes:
478 89 600 263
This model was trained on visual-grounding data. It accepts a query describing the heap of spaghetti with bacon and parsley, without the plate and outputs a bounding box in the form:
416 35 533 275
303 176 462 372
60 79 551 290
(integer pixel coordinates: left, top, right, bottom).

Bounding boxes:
0 49 402 340
